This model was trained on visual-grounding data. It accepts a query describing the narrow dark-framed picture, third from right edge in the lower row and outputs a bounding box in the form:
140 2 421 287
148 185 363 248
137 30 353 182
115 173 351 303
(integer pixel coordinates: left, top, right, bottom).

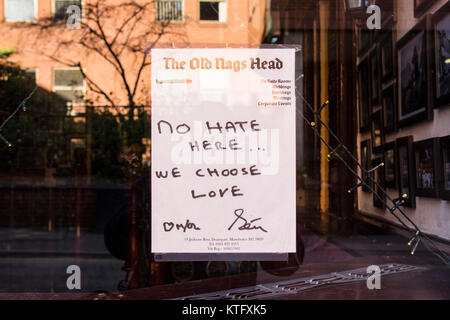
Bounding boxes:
395 136 416 208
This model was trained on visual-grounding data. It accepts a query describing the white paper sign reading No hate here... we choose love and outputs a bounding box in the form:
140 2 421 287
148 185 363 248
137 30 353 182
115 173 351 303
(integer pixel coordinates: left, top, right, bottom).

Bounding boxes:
151 49 296 254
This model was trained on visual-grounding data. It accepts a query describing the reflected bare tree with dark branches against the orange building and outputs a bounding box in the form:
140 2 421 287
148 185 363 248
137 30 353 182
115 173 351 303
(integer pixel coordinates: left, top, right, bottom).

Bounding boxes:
26 0 183 115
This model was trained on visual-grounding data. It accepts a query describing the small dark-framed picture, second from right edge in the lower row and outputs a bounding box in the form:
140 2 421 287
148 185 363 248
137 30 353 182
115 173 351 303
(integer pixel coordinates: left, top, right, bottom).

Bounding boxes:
414 138 441 198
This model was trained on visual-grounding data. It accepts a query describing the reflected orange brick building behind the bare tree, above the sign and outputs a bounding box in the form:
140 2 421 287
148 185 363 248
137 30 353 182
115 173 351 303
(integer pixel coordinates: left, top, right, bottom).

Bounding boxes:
0 0 265 178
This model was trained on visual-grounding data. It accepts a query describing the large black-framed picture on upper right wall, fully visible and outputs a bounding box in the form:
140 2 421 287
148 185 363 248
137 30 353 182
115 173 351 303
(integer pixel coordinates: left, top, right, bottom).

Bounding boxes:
397 15 434 127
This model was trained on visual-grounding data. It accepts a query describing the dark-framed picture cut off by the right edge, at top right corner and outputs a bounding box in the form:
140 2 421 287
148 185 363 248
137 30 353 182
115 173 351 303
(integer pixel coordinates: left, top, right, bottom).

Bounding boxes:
432 2 450 107
